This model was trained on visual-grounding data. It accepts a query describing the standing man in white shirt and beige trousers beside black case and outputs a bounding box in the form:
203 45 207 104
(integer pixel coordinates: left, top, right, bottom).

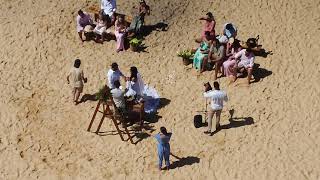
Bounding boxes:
203 81 228 135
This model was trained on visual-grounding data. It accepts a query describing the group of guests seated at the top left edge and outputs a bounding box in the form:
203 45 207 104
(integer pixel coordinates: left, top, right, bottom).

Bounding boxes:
76 0 150 52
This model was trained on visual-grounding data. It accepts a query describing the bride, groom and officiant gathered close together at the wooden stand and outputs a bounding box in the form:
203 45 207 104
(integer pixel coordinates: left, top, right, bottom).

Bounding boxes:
107 63 144 112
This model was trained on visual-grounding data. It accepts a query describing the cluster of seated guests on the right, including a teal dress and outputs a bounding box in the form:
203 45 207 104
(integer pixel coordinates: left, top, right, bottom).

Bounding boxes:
192 12 256 84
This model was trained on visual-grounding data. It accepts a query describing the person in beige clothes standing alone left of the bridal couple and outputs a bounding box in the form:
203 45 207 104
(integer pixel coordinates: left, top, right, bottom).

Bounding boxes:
67 59 87 105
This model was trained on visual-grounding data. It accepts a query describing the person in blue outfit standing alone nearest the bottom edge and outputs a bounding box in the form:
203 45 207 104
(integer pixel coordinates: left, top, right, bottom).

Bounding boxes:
155 127 172 170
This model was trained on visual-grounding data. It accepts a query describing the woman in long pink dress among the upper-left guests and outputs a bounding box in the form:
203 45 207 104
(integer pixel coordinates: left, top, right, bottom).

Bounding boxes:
114 15 126 52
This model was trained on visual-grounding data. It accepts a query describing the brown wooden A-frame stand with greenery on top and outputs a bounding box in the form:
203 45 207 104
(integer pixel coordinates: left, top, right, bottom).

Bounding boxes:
87 86 134 144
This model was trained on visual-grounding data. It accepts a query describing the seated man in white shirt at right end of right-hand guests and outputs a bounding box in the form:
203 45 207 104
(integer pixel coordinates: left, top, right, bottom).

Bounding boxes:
234 48 255 84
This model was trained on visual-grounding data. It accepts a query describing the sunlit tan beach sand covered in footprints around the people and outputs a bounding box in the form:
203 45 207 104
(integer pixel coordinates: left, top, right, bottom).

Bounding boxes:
0 0 320 180
